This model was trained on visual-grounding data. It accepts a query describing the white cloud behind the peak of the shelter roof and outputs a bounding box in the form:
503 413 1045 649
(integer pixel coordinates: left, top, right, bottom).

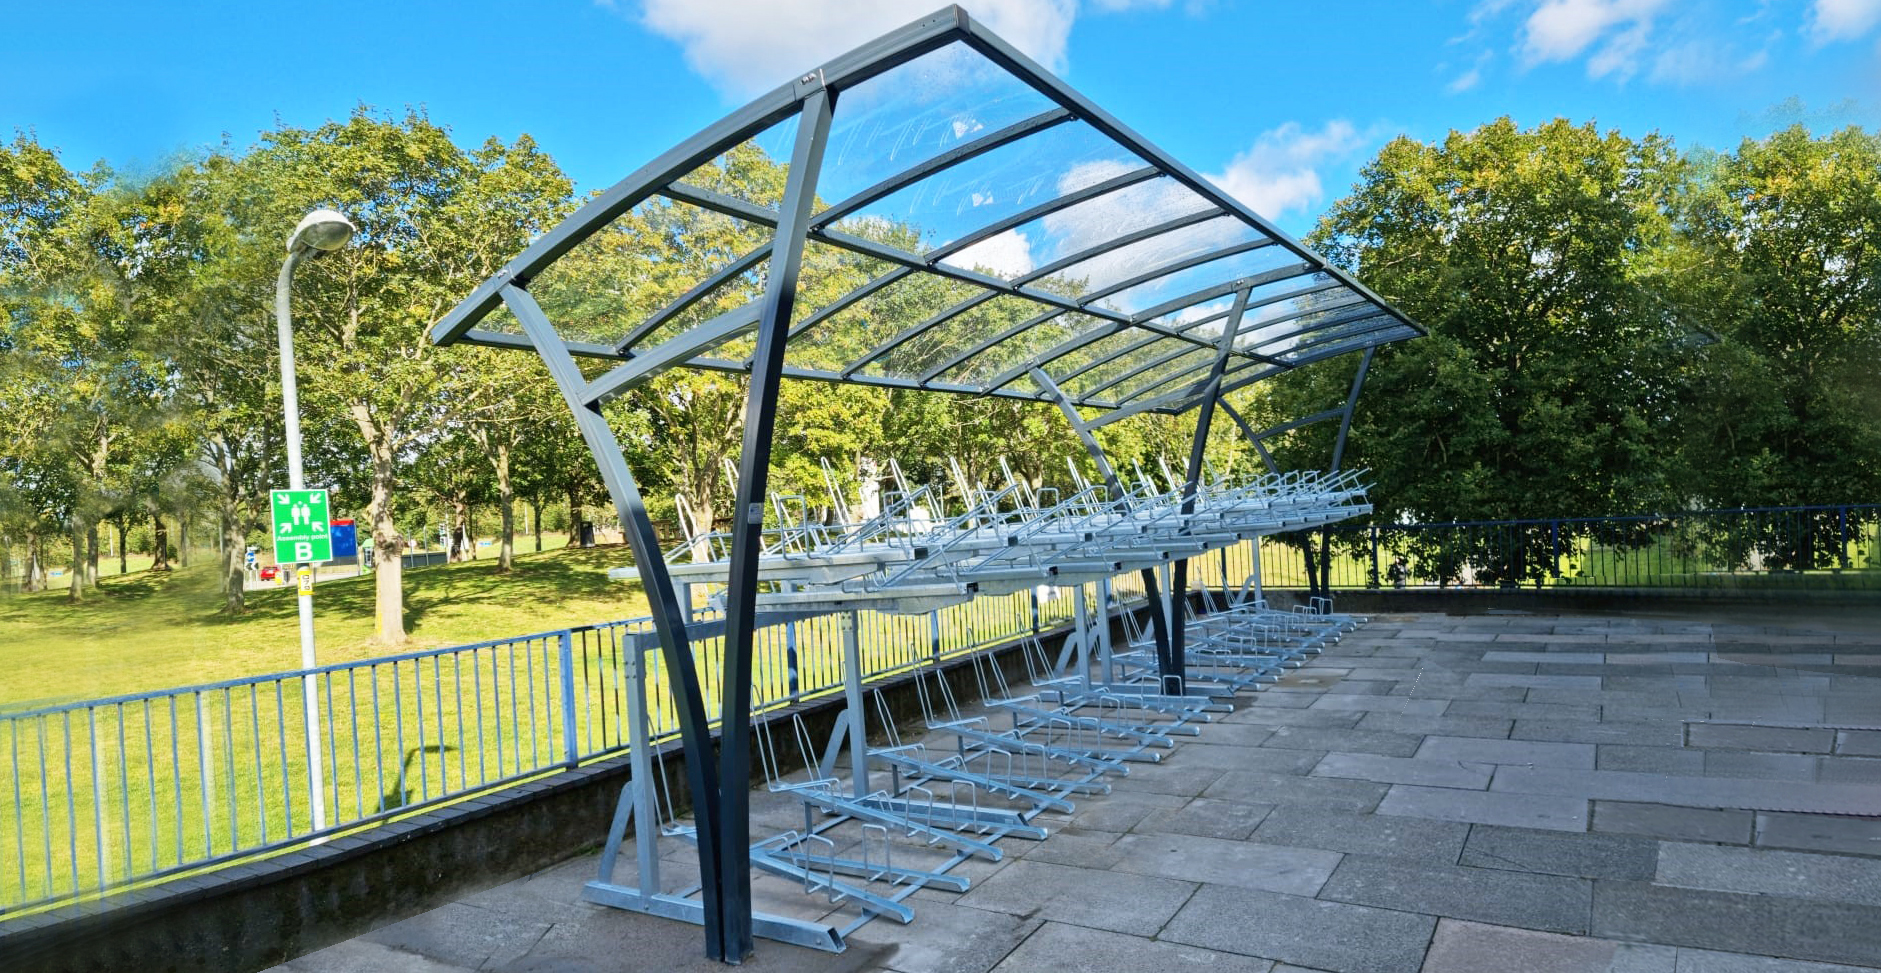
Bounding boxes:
632 0 1075 96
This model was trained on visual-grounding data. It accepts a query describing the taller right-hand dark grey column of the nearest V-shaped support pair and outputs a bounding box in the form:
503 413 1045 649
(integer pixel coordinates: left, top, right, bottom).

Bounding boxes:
714 75 833 964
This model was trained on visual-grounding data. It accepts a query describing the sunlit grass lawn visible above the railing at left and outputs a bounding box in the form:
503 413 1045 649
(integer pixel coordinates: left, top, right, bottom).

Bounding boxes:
0 538 647 711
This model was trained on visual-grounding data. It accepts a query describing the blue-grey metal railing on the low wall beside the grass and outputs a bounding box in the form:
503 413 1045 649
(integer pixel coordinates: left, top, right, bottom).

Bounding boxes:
0 575 1158 920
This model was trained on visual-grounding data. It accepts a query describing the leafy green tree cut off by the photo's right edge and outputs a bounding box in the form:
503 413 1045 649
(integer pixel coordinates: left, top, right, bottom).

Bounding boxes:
1680 126 1881 506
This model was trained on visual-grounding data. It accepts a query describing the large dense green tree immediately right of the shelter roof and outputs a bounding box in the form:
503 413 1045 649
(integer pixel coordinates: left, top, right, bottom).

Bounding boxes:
1286 119 1691 521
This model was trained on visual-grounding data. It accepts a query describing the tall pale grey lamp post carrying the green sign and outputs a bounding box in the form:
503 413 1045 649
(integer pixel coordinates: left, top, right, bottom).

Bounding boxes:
275 209 354 832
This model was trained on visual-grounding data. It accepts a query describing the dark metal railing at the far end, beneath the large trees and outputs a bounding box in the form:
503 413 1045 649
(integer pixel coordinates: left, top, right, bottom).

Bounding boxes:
1260 504 1881 589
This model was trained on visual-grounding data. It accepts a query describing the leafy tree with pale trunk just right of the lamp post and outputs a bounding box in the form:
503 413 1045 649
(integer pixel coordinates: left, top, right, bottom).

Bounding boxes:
227 107 570 644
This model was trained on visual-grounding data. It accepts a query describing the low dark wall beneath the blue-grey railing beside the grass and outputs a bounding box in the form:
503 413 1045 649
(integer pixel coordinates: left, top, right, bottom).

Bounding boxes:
0 613 1113 973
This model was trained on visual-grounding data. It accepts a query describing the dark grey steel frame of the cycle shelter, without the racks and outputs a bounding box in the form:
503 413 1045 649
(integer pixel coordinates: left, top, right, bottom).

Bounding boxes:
431 8 1422 962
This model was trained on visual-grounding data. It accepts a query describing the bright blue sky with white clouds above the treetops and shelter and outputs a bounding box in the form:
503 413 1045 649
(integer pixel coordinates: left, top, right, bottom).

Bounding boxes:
0 0 1881 231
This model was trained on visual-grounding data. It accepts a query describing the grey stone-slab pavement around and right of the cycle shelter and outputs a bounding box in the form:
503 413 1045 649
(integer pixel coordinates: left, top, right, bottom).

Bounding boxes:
275 614 1881 973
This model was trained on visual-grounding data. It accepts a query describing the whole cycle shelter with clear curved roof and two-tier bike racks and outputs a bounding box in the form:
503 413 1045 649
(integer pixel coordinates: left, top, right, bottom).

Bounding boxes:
431 8 1422 962
